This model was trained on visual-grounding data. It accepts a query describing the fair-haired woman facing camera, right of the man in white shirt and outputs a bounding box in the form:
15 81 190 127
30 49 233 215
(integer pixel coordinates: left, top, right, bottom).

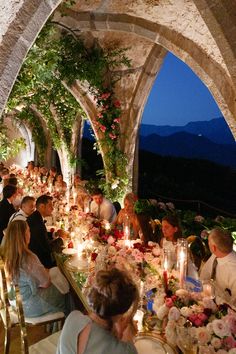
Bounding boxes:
114 193 142 239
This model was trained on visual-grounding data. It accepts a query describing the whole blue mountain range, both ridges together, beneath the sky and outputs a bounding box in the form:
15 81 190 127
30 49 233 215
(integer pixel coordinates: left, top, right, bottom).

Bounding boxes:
84 117 236 169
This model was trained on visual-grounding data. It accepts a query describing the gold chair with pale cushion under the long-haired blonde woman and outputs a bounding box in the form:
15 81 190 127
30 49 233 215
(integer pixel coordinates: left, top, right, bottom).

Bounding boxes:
0 258 65 354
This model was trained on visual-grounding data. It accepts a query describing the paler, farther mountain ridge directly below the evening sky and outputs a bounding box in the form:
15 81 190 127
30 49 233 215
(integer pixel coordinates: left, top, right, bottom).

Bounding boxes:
140 117 235 144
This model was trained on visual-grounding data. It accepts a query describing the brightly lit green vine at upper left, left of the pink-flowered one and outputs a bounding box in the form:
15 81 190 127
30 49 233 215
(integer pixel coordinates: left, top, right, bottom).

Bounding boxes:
7 22 85 164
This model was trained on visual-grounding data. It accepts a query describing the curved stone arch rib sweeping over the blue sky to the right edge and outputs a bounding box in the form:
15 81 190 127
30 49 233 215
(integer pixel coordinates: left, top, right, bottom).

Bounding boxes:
57 10 236 137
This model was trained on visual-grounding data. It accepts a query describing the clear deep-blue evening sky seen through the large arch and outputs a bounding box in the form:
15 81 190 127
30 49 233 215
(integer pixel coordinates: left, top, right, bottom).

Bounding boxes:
142 53 222 126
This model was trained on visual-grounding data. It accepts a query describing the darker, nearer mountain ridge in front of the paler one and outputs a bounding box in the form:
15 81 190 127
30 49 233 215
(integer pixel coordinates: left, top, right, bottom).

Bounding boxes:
139 132 236 169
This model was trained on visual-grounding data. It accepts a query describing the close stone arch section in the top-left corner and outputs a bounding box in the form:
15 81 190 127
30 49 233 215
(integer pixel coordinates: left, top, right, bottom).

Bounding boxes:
0 0 61 115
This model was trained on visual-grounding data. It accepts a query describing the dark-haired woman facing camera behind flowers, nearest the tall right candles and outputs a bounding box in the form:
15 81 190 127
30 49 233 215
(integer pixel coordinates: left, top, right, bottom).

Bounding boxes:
160 214 182 249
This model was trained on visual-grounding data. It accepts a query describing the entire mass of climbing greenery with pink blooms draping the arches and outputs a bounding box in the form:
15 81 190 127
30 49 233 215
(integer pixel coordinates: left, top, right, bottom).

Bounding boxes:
7 17 130 200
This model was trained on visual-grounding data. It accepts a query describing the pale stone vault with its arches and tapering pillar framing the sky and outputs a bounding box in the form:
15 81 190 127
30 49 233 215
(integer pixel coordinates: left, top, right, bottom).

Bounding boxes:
0 0 236 194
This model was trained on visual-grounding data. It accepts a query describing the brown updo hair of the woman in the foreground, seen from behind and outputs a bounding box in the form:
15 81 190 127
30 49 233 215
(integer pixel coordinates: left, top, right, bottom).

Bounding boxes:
88 268 139 319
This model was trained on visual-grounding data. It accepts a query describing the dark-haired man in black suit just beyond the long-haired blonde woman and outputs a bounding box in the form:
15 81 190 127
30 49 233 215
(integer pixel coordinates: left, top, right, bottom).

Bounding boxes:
27 194 63 268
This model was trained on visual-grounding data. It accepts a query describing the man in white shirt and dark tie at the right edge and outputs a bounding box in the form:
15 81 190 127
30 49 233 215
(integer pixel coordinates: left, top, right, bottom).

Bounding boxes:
200 228 236 306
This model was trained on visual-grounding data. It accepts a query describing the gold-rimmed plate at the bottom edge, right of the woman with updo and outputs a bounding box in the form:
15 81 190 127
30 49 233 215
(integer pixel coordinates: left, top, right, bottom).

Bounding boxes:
134 333 176 354
